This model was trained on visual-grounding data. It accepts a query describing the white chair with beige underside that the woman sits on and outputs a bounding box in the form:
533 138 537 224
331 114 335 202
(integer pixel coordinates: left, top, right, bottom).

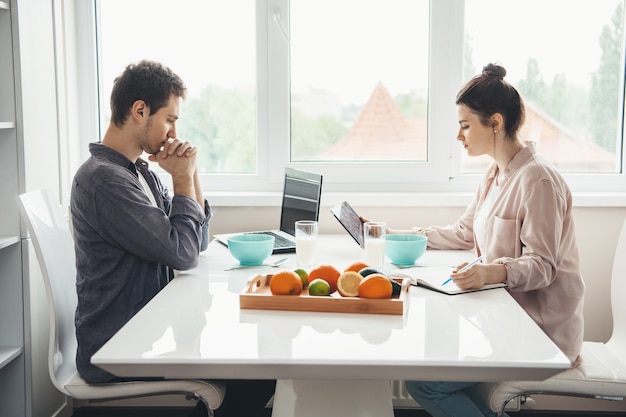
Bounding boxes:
480 216 626 413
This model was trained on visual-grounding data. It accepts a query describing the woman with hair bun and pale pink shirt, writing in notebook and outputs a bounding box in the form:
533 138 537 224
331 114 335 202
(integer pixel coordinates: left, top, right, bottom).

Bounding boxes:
389 64 585 417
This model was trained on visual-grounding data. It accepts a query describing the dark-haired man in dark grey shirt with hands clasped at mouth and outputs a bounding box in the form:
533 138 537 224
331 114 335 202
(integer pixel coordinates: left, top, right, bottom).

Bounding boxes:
70 61 275 415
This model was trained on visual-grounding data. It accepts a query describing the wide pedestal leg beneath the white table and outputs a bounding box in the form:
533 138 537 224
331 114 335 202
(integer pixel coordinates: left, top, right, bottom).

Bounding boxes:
272 379 393 417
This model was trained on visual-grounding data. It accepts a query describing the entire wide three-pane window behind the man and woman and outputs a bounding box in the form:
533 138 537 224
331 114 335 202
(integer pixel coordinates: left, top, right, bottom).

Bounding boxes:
83 0 626 192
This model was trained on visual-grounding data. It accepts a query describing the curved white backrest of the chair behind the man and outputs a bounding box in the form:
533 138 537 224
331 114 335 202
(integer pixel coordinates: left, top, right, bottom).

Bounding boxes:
18 190 77 395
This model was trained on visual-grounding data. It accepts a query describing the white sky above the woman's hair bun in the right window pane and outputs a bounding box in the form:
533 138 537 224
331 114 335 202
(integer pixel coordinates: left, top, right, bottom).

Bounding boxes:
466 0 619 83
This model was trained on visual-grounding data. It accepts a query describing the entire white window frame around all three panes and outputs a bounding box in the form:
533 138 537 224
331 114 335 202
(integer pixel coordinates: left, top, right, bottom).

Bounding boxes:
72 0 626 194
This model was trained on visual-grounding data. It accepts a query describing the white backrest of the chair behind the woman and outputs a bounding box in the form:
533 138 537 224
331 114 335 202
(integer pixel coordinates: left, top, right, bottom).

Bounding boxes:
607 219 626 350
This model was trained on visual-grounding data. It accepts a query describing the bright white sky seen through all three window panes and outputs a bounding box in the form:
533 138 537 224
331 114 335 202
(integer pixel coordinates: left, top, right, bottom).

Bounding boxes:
100 0 622 103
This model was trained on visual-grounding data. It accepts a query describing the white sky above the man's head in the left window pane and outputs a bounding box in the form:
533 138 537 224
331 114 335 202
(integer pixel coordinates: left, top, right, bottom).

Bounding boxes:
100 0 256 96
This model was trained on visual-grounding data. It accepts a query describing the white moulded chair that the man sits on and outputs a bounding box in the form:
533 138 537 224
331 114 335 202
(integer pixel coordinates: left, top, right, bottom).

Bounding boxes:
18 190 225 416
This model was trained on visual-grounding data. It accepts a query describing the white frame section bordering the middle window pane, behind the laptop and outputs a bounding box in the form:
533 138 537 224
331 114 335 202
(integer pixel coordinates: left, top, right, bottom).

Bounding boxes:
260 0 470 192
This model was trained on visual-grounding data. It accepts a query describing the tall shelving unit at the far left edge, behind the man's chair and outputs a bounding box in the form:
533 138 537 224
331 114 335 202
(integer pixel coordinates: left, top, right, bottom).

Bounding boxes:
0 0 26 417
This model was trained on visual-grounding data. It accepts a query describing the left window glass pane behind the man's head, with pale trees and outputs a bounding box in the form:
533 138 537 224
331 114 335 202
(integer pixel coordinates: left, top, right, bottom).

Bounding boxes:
98 0 257 173
